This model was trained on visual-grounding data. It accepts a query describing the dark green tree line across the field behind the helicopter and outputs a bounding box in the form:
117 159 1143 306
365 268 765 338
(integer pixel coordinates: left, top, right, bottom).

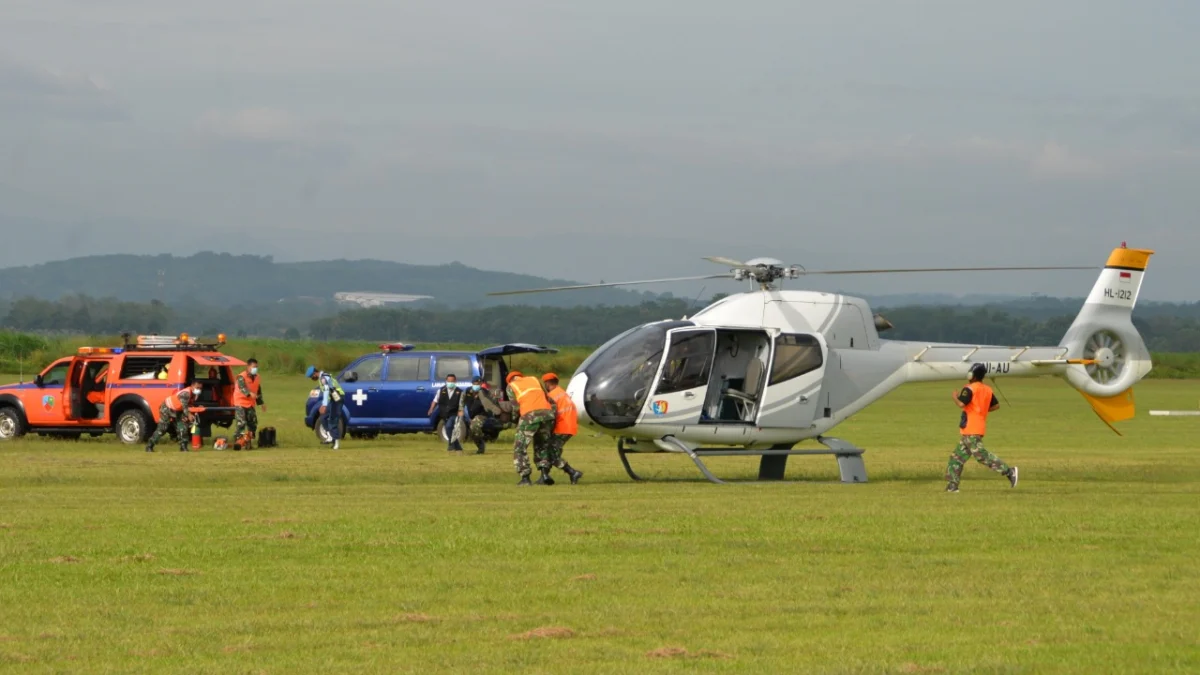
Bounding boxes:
7 295 1200 353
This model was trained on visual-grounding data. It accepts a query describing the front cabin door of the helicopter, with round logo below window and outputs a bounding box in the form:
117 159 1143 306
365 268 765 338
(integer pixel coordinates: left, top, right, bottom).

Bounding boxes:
640 328 716 426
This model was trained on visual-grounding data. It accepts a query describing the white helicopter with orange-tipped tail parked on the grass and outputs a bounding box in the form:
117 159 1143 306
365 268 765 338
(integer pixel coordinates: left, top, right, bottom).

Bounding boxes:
488 241 1154 483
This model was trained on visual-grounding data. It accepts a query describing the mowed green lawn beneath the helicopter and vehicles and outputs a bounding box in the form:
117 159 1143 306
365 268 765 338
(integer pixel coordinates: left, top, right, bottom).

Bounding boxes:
0 375 1200 674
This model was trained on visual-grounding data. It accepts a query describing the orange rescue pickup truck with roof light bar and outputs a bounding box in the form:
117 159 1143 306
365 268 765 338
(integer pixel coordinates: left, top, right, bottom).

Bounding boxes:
0 333 246 446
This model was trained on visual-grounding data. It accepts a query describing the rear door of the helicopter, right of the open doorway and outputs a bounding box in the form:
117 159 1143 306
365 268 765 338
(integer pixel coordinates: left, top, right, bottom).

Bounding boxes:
758 333 828 429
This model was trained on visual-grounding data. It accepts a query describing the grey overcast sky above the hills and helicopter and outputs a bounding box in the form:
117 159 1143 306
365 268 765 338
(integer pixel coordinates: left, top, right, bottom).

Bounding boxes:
0 0 1200 300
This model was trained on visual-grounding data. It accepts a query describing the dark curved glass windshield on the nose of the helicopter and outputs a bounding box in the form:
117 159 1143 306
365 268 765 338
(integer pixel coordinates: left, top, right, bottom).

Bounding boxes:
578 321 695 429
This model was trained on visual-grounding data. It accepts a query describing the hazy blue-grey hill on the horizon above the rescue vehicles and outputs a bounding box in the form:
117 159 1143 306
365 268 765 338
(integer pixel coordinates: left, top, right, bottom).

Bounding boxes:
0 252 670 309
